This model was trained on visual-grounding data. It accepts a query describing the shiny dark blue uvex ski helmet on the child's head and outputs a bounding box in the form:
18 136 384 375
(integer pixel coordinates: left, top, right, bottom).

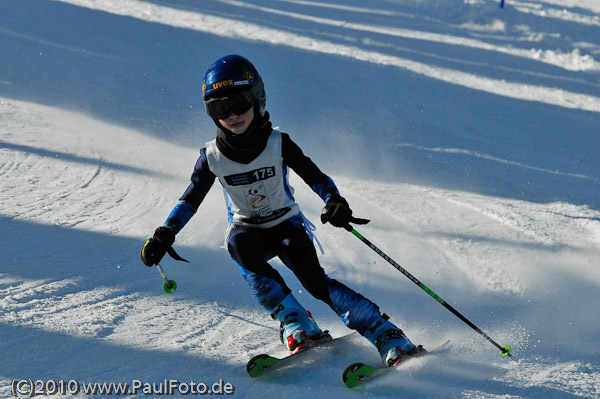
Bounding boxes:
202 54 267 117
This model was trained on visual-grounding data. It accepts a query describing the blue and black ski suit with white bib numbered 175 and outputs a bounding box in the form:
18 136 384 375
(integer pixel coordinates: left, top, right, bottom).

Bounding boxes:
165 130 381 335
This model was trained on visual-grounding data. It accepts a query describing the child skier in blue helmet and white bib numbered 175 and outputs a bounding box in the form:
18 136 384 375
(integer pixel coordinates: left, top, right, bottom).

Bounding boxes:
141 55 421 365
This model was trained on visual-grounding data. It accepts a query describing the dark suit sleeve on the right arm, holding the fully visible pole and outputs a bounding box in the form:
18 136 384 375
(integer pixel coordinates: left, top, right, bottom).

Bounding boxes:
281 133 340 202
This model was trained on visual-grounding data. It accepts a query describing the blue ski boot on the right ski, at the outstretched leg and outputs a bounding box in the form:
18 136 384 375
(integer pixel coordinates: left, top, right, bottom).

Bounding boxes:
364 313 425 367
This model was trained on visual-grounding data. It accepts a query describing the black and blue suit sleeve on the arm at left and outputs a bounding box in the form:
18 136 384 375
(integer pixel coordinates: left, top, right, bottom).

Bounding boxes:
164 148 216 234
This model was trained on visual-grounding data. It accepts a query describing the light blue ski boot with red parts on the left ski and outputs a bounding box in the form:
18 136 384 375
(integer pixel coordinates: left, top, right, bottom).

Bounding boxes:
271 294 331 355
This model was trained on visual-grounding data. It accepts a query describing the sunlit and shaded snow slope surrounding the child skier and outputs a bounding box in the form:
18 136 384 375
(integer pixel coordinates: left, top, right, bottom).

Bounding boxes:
0 0 600 399
